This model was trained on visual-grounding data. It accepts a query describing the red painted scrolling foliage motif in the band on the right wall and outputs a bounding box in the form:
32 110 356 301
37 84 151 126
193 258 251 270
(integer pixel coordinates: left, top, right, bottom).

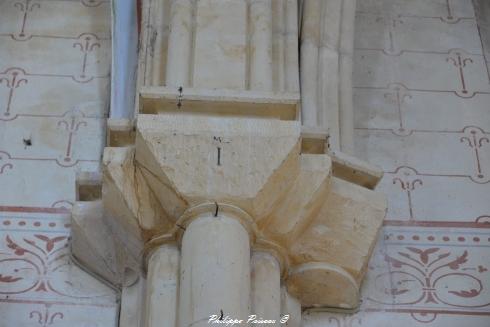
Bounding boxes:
370 246 490 308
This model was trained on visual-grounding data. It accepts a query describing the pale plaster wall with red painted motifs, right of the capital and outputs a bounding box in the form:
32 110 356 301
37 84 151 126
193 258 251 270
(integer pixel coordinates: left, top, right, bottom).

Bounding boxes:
303 0 490 327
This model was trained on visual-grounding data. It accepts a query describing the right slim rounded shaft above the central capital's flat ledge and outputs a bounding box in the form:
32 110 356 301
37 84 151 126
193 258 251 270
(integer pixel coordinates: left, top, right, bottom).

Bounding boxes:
248 0 272 91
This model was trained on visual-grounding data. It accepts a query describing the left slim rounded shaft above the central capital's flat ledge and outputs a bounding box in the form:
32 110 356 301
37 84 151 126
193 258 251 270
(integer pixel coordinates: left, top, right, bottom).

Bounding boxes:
166 0 194 87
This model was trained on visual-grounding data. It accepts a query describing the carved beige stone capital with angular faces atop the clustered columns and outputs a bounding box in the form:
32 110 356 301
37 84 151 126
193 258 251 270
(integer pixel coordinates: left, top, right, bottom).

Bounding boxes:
74 113 386 309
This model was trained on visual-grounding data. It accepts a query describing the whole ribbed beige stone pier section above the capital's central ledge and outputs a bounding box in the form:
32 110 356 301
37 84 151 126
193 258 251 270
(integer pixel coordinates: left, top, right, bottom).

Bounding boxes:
139 0 299 93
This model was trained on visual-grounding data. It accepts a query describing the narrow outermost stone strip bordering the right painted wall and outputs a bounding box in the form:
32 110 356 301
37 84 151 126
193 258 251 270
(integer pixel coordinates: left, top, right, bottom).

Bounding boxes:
339 0 356 154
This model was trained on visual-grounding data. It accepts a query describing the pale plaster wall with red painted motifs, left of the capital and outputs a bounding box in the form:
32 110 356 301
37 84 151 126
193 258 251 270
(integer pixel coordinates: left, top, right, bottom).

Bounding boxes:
0 0 119 327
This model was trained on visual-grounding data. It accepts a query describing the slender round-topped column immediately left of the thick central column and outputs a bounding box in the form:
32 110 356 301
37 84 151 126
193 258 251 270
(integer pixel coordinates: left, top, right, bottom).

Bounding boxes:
145 244 180 327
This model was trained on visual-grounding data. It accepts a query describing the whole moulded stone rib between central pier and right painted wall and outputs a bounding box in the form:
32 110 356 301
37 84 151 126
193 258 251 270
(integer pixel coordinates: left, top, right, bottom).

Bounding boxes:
300 0 356 153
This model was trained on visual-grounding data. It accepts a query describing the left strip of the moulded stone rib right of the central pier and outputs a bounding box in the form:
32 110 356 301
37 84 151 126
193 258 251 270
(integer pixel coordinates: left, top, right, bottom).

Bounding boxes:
300 0 323 127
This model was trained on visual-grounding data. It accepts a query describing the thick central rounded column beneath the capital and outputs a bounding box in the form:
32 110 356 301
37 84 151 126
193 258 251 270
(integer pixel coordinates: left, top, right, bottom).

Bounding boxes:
178 213 250 327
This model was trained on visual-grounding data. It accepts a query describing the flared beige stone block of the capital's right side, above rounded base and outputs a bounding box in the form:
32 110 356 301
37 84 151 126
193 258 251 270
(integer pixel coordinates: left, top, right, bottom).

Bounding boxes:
291 177 386 283
